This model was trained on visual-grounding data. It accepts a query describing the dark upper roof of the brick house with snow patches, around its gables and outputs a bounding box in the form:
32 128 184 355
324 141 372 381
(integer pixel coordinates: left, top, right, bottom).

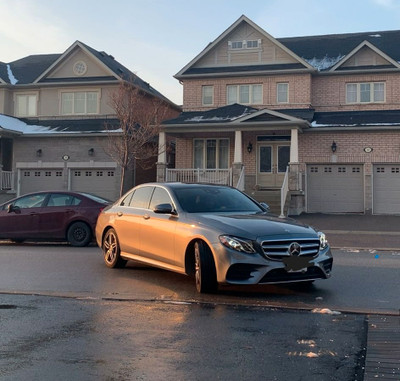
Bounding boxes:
175 15 400 79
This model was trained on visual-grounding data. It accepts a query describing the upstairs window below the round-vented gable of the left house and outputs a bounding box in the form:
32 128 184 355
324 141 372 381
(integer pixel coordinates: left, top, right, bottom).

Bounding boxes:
61 91 99 115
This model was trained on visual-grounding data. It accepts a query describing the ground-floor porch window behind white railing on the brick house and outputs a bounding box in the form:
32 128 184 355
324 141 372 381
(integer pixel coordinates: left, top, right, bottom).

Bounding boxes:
193 139 229 169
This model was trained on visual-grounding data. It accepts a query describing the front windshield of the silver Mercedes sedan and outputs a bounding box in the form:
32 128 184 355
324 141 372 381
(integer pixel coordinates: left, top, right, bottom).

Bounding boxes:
174 185 263 213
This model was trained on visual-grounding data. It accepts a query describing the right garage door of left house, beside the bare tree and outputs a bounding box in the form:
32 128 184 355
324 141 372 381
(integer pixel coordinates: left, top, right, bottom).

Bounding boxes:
70 168 119 201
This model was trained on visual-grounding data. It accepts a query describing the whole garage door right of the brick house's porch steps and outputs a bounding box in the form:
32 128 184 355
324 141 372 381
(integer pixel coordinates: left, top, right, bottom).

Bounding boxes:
307 164 364 213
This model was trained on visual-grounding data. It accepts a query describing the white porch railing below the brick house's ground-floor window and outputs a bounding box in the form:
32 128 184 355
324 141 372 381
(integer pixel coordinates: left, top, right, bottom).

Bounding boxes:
166 168 232 185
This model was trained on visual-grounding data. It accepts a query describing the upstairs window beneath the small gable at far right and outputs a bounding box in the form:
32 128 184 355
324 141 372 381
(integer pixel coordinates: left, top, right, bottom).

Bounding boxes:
346 82 385 103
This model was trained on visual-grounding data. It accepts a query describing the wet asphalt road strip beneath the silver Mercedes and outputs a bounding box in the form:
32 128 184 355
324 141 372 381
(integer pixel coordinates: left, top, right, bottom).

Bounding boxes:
0 243 400 315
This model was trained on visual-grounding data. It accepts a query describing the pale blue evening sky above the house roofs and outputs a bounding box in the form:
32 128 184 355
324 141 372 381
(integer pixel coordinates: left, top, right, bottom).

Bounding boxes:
0 0 400 104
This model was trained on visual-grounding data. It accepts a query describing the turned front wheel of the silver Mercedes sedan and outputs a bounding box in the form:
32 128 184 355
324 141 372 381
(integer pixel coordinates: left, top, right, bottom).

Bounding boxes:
194 241 218 293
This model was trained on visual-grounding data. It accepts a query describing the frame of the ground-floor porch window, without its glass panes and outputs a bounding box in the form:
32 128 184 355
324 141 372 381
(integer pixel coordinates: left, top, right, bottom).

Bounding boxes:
193 138 230 170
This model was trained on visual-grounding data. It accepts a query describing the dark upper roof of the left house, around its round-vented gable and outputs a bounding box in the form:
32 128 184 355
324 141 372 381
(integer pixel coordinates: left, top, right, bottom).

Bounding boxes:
0 41 174 105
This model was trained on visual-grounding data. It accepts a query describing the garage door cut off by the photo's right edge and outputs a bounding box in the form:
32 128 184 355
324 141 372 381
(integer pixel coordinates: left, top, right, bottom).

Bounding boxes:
373 164 400 214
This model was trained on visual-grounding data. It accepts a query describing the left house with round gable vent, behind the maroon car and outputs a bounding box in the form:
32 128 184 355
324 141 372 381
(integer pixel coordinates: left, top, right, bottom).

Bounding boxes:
0 41 181 202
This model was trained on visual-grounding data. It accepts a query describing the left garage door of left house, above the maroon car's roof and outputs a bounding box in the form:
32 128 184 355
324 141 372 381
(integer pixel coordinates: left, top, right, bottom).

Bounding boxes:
20 168 66 195
